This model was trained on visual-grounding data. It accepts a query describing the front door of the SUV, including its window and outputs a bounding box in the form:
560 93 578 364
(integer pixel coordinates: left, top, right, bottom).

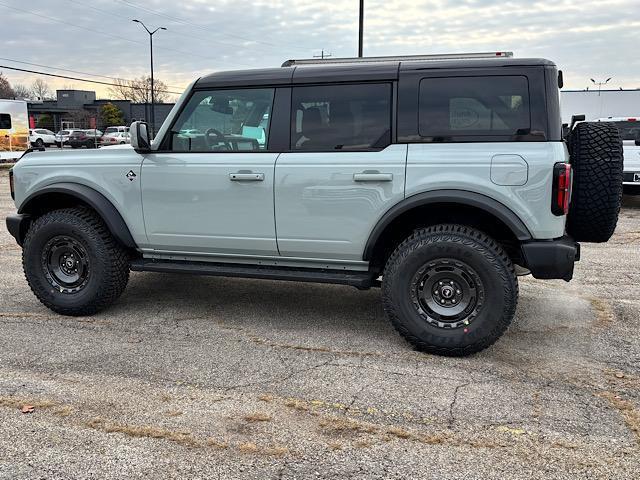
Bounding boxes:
141 88 278 256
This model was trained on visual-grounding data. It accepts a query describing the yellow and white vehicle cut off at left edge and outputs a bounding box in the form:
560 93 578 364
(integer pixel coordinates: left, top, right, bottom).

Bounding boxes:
0 100 29 162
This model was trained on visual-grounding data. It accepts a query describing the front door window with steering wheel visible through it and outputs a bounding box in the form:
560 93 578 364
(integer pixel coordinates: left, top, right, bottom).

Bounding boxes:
170 88 274 152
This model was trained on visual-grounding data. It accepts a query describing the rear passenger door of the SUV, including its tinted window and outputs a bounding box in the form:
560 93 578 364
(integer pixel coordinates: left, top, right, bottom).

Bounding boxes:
275 82 407 262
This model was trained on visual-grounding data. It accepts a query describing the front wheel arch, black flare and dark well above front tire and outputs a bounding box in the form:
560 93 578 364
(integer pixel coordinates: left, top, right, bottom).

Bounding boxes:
18 183 137 249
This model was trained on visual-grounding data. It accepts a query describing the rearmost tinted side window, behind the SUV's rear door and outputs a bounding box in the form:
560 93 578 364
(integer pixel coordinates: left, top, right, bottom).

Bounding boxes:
419 76 531 141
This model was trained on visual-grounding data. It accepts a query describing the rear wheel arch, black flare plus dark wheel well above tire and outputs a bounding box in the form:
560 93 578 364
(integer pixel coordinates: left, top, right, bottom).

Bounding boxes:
363 190 532 265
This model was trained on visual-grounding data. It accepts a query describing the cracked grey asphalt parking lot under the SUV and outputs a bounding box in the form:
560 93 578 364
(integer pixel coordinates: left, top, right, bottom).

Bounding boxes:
0 170 640 479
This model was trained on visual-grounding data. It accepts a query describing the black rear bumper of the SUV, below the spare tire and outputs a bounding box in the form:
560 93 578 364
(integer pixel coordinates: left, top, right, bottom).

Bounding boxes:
522 236 580 282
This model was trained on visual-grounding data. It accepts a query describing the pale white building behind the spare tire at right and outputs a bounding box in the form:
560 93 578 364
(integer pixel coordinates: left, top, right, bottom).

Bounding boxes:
560 90 640 123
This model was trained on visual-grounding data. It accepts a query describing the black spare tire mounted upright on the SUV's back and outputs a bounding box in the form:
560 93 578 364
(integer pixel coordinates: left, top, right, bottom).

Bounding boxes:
567 122 623 243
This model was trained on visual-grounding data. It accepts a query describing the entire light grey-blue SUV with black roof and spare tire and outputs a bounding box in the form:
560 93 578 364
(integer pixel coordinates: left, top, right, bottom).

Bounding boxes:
7 54 622 355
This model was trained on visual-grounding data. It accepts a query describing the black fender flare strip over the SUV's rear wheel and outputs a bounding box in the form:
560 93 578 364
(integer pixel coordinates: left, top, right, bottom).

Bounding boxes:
362 190 532 261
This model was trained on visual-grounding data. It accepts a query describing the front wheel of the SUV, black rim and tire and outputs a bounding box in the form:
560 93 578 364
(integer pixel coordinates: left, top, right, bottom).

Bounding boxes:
22 208 129 315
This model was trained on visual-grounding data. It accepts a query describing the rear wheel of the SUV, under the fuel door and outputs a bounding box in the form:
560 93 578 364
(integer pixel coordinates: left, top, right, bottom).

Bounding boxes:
382 225 518 356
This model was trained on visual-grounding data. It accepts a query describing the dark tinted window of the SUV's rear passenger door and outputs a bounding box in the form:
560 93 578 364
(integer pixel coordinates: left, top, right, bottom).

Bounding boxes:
291 83 391 151
